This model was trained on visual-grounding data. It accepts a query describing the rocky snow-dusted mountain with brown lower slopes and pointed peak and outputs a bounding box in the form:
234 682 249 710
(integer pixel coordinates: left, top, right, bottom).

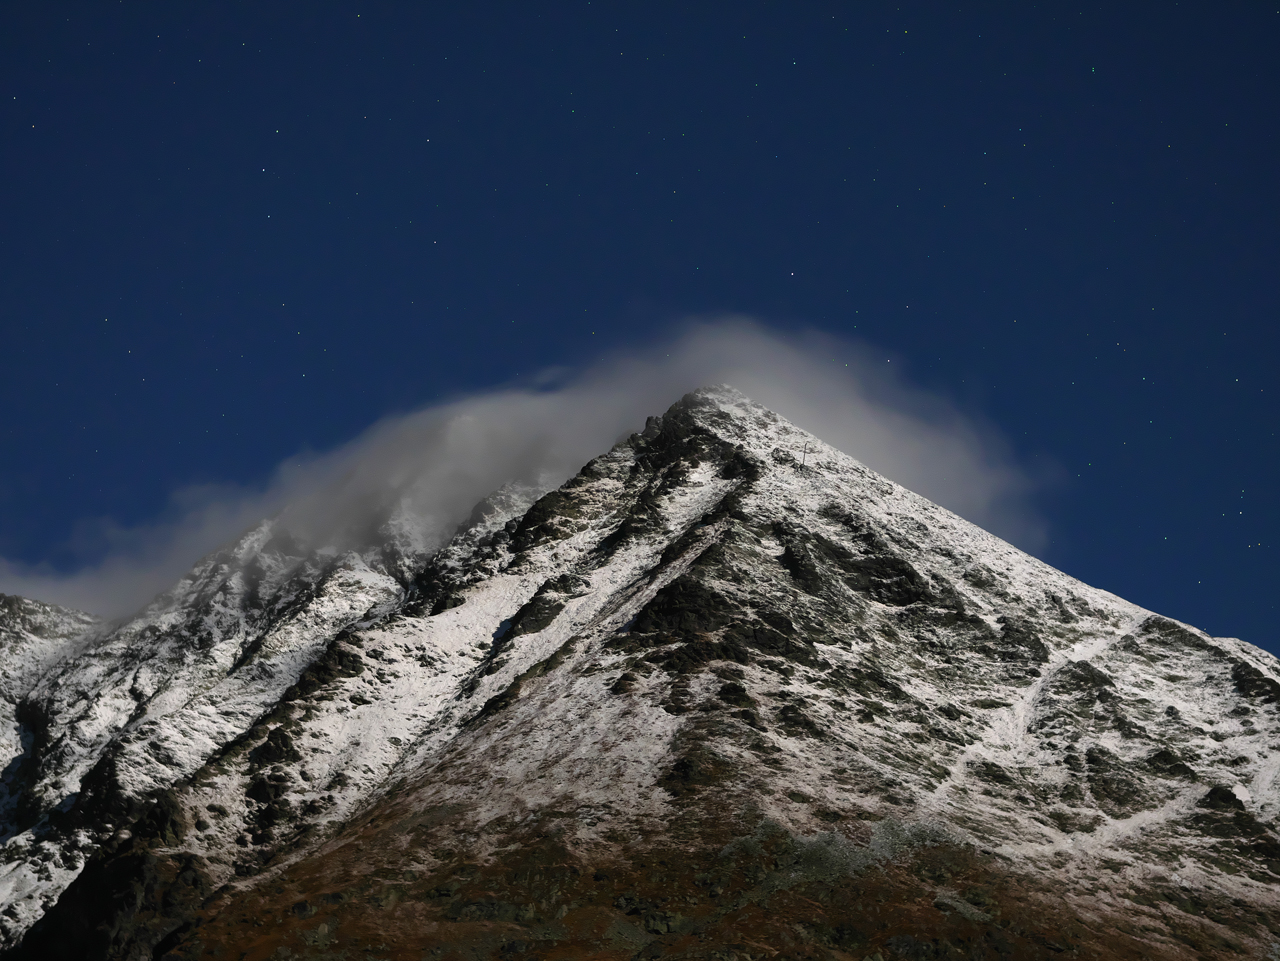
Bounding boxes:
0 388 1280 961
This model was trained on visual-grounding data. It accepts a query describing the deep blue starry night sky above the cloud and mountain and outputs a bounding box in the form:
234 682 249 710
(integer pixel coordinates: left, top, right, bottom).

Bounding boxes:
0 0 1280 653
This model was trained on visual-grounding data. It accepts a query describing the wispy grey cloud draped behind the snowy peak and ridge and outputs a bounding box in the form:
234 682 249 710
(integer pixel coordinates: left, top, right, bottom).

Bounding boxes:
0 319 1046 616
